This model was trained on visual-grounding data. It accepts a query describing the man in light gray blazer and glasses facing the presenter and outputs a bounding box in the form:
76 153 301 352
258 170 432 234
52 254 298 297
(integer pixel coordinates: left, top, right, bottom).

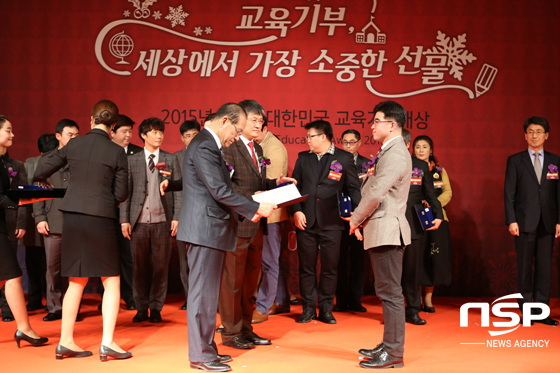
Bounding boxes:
350 101 412 368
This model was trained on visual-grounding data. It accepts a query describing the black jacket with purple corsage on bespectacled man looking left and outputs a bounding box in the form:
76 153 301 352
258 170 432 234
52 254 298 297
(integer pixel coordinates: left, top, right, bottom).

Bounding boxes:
291 147 361 231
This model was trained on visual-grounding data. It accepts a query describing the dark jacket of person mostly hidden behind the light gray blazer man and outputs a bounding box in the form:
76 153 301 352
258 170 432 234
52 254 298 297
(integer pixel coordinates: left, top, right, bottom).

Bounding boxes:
406 157 443 239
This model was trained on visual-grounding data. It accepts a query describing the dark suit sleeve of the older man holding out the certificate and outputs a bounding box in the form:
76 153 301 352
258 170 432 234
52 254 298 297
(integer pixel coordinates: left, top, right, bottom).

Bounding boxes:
193 144 259 219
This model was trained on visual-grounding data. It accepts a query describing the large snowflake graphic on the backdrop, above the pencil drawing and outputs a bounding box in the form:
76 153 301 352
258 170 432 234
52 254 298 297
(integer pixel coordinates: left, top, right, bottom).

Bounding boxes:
424 31 476 80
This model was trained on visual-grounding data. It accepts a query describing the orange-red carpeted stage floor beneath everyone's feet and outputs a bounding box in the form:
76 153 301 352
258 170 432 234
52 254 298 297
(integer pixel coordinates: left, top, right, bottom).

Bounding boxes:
0 295 560 373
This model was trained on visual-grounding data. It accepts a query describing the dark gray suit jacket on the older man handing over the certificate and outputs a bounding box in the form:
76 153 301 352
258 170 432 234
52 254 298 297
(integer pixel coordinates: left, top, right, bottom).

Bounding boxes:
177 128 259 251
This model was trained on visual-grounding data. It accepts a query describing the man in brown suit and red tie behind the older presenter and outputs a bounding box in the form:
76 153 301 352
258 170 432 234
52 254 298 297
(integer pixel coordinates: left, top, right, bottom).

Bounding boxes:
218 100 277 349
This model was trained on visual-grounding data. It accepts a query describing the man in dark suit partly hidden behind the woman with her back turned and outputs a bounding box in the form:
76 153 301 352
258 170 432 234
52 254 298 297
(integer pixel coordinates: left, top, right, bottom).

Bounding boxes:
33 119 80 321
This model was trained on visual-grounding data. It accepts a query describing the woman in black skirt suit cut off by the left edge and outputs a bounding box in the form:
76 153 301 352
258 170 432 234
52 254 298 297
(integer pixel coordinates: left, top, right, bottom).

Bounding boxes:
0 115 48 347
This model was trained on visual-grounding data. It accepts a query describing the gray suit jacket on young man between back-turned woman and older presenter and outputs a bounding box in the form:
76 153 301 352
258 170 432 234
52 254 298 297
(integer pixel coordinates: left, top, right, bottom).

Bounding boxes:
120 149 181 229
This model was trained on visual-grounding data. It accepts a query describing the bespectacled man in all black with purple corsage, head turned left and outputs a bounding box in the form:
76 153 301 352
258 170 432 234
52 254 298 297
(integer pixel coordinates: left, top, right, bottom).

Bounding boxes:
291 120 361 324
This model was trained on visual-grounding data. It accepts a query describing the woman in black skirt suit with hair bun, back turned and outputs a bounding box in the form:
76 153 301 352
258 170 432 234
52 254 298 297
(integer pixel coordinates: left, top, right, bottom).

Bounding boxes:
35 100 132 361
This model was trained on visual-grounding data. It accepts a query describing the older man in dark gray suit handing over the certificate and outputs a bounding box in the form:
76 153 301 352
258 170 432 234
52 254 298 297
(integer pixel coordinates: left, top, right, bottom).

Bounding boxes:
170 103 276 372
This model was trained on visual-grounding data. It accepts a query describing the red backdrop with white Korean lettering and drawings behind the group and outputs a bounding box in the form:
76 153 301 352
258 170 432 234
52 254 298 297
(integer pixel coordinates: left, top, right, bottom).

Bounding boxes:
0 0 560 297
